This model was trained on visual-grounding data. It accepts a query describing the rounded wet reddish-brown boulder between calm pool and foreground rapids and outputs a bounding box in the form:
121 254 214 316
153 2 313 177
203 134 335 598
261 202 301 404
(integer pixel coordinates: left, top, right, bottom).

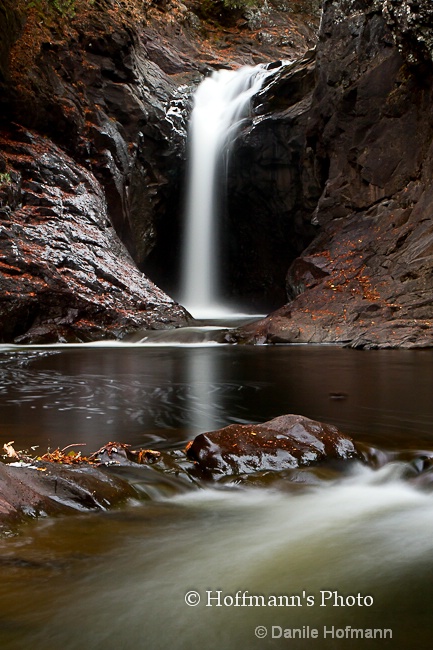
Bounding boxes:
187 415 359 476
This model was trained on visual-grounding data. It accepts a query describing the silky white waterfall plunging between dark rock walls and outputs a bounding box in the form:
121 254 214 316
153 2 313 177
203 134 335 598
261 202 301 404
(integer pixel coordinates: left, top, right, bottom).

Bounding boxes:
180 66 272 318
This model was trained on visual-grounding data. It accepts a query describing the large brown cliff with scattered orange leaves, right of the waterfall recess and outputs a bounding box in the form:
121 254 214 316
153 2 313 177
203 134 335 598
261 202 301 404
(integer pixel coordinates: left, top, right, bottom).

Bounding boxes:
238 0 433 347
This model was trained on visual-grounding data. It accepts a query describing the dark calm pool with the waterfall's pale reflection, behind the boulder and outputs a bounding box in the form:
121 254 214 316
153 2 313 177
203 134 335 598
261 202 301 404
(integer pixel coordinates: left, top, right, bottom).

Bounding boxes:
0 345 433 450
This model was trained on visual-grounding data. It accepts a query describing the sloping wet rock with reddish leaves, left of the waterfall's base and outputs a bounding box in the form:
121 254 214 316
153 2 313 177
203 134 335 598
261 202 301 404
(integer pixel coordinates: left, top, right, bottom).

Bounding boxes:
0 123 188 343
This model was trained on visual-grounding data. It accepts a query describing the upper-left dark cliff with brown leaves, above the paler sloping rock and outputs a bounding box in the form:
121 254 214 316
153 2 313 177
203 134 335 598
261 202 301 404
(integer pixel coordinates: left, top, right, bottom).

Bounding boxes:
1 1 191 294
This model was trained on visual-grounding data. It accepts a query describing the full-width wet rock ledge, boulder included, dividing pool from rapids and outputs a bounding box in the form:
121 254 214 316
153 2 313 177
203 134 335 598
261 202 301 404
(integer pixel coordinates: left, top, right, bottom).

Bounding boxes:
0 415 433 534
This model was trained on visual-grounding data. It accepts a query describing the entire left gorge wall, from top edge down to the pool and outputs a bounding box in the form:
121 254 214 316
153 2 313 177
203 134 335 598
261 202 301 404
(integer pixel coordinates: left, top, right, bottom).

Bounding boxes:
0 0 194 342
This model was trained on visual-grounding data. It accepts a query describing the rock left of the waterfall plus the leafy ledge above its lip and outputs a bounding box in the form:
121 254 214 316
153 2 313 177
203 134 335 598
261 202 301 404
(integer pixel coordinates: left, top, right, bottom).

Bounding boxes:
0 0 317 342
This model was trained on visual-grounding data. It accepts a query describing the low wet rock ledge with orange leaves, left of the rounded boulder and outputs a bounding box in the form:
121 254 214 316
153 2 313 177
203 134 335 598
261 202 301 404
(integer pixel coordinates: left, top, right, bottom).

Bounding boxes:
0 442 196 535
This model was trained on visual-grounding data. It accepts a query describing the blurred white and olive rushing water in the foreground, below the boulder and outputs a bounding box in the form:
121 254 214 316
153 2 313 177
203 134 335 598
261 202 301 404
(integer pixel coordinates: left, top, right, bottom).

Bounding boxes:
0 466 433 650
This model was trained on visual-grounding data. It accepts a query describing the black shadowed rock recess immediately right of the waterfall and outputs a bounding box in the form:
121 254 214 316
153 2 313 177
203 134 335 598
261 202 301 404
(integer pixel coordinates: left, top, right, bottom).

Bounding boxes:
224 51 321 311
